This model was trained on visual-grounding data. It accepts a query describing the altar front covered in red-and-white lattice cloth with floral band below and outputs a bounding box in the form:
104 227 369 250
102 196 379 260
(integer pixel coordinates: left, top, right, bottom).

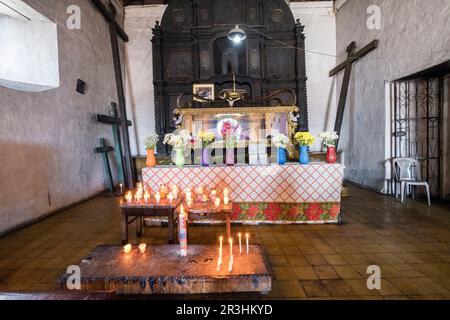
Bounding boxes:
142 163 344 224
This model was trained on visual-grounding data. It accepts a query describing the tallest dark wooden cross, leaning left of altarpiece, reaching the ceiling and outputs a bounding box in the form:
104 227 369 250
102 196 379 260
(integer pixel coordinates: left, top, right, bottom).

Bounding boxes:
91 0 134 188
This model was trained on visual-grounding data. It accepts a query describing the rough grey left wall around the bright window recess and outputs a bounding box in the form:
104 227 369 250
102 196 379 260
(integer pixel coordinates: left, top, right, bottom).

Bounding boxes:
0 0 124 234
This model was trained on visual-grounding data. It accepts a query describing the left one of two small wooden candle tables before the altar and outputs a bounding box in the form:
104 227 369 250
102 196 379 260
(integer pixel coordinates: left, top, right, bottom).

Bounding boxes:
120 198 183 244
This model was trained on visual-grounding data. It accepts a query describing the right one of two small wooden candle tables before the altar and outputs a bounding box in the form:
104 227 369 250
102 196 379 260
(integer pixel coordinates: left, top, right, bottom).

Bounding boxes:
175 201 233 238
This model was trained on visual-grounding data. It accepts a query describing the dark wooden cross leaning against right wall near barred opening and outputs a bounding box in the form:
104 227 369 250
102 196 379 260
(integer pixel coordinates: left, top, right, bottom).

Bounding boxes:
330 40 378 147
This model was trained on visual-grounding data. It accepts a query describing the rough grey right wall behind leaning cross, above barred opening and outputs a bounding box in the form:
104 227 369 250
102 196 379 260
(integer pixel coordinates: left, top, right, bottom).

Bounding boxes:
336 0 450 191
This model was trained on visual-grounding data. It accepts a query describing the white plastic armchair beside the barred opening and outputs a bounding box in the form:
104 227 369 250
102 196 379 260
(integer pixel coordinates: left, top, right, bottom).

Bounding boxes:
393 158 431 206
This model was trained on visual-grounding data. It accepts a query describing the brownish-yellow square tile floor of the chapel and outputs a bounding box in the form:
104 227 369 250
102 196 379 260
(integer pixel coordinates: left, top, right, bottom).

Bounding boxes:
0 188 450 299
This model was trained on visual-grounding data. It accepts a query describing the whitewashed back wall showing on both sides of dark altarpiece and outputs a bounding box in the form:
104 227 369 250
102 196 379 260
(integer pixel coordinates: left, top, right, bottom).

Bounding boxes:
125 1 336 155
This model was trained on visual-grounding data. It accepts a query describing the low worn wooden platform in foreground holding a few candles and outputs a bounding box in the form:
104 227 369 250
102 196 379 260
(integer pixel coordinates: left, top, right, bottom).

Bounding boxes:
59 245 272 295
